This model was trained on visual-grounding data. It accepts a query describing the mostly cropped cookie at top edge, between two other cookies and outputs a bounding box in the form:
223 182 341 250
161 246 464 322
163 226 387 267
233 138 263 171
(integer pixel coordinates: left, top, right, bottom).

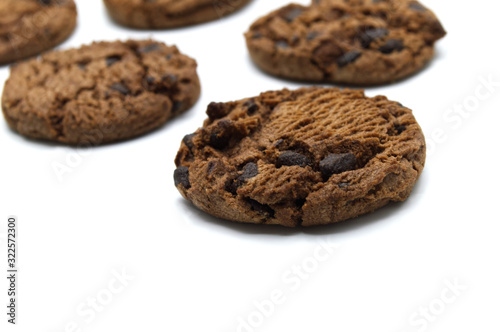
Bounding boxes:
104 0 254 29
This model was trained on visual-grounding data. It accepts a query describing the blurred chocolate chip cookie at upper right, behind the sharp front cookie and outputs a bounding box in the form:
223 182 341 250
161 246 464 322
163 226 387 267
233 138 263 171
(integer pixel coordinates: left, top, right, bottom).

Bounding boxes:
246 0 446 85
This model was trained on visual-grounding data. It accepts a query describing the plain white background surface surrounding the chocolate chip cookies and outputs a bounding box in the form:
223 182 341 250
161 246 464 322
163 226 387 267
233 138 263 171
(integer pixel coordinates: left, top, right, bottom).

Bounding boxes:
0 0 500 332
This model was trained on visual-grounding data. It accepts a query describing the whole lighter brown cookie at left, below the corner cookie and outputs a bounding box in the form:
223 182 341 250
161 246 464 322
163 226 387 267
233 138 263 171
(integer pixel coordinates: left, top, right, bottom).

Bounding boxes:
2 40 200 145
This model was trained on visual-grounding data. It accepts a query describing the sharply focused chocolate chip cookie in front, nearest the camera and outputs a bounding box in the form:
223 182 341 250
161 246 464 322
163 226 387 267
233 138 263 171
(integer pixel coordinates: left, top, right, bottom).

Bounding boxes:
174 88 425 227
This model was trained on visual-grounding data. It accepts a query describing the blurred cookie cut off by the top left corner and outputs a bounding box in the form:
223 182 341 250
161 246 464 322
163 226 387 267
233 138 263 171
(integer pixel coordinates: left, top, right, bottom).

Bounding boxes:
0 0 77 64
